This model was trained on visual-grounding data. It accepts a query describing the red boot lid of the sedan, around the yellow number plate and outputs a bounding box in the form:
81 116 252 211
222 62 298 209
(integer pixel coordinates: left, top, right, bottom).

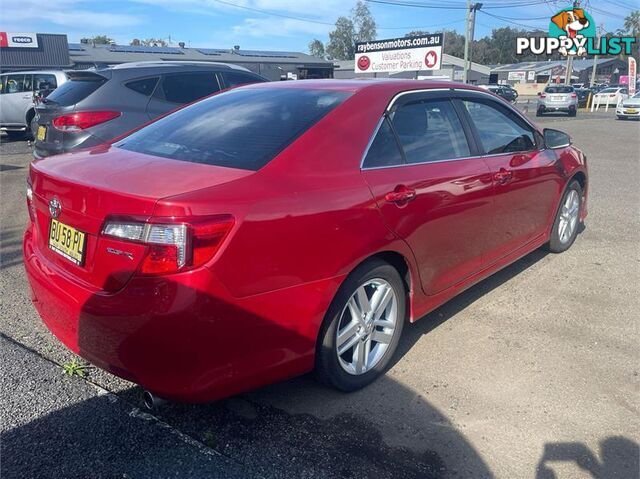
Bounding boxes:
31 146 253 292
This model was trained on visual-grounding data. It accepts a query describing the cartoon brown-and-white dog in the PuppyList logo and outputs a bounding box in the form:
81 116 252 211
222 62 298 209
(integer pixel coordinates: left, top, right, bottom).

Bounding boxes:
549 8 596 56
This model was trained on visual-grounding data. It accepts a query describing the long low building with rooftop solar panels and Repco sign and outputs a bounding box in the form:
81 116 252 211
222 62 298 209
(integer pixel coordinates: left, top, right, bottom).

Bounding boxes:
0 32 334 80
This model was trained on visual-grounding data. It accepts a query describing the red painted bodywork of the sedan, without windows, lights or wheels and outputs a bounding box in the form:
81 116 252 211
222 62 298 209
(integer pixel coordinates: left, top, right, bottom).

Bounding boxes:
24 81 587 401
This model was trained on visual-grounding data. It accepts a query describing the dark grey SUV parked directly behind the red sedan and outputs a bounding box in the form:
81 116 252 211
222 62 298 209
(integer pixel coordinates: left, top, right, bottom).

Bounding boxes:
34 61 267 157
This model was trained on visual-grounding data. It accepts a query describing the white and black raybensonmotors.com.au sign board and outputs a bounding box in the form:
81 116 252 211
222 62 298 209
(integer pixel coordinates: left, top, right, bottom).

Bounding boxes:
354 33 442 73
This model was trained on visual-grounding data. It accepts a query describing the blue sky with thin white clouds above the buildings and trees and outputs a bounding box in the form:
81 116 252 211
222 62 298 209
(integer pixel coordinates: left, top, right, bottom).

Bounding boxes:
0 0 640 51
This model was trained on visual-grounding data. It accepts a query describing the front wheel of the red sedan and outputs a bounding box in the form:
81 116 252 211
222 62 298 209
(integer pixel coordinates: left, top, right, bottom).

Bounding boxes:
547 180 582 253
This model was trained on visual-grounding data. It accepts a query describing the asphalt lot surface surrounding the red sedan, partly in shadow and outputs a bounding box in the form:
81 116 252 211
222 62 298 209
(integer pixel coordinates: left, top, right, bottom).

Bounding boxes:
0 110 640 478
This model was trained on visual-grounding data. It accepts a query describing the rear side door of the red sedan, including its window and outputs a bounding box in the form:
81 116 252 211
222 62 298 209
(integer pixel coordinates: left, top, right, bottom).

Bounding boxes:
362 92 493 294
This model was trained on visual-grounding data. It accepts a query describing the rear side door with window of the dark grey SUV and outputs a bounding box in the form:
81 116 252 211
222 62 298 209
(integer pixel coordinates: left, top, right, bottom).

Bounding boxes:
147 71 222 119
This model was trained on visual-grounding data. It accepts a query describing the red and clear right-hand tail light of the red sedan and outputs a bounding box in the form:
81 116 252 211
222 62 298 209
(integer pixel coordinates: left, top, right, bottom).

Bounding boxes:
102 215 234 275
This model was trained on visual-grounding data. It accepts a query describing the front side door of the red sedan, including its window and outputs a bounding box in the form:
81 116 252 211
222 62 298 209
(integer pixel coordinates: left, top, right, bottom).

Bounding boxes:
458 94 563 264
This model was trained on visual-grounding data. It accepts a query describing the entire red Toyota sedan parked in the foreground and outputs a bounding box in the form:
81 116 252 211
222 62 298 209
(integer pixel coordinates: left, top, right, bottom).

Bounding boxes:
24 80 587 401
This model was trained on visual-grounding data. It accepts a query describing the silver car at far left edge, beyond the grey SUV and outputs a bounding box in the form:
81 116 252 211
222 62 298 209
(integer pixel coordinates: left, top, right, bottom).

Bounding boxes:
0 70 67 138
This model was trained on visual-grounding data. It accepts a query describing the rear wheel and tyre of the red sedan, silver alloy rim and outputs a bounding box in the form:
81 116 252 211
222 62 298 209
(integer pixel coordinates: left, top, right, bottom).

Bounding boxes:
315 259 406 392
